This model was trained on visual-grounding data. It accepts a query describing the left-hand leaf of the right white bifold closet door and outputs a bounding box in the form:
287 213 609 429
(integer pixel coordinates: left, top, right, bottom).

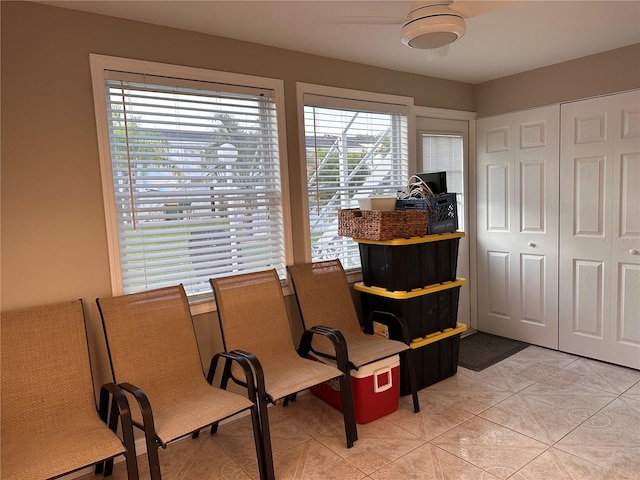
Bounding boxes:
559 96 613 360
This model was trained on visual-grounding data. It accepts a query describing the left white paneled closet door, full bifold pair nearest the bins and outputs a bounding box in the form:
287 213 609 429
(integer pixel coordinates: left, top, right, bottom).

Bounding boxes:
477 106 559 348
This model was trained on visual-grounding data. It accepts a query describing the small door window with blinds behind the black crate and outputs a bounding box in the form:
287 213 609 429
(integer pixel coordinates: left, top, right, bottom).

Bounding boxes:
422 133 464 231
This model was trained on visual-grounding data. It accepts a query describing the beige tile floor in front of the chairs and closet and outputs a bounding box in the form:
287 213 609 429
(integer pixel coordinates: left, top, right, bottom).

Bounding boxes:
94 346 640 480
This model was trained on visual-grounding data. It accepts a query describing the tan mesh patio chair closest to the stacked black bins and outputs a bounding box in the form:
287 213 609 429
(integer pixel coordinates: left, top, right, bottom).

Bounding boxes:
287 260 420 413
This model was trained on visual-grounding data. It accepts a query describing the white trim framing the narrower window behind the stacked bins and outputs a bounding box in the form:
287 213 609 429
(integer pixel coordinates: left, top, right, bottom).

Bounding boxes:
296 82 417 262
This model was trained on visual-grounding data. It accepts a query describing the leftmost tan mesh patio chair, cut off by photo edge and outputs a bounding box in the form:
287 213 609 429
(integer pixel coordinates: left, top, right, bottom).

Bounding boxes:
0 300 138 480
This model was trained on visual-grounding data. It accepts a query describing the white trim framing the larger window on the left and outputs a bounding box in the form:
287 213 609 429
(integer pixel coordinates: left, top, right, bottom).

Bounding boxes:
89 53 293 315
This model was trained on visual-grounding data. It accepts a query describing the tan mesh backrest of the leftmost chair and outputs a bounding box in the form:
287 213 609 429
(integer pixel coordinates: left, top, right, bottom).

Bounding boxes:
0 300 97 440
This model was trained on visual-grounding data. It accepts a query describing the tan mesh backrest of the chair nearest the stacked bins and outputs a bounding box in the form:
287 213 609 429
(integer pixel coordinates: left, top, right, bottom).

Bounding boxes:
287 260 363 343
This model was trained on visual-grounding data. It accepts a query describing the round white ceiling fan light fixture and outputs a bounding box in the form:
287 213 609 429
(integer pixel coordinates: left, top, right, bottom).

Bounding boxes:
401 1 466 49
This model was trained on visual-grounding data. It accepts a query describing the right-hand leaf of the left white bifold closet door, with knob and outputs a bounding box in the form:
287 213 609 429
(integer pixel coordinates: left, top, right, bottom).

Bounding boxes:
514 105 560 348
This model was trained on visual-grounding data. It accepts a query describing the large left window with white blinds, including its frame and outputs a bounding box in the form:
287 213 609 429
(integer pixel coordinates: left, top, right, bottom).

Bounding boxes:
92 55 288 298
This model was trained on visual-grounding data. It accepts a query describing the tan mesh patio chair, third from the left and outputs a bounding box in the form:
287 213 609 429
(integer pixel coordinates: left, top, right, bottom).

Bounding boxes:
210 269 358 454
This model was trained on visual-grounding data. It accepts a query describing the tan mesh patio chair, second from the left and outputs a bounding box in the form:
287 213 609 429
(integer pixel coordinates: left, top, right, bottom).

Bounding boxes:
96 285 274 480
